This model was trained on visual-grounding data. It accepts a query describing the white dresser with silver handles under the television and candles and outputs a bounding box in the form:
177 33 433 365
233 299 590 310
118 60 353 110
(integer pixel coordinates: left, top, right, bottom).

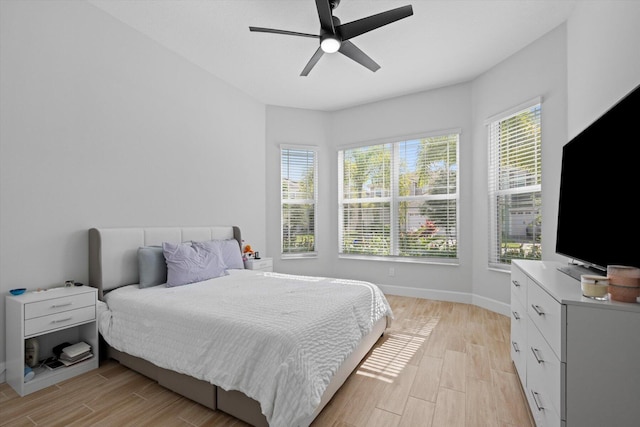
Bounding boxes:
511 260 640 427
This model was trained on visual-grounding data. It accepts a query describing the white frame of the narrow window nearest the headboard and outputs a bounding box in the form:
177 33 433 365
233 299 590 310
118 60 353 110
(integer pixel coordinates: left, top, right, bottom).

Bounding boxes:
279 144 319 260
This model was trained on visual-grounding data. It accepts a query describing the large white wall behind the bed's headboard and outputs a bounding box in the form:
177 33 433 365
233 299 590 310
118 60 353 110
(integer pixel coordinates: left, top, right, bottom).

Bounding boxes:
0 1 266 379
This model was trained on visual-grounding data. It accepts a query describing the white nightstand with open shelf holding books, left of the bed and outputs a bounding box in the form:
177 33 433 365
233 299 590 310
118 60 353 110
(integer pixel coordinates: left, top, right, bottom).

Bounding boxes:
6 286 99 396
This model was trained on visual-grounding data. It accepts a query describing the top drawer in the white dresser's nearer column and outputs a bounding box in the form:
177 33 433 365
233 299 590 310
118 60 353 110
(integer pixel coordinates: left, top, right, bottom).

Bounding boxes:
527 281 562 359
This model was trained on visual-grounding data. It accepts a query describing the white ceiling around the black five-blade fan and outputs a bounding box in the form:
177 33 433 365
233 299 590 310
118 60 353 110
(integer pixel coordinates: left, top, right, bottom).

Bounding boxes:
88 0 576 111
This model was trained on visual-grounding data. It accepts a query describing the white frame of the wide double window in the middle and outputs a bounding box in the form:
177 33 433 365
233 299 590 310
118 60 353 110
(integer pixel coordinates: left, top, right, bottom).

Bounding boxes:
336 128 462 265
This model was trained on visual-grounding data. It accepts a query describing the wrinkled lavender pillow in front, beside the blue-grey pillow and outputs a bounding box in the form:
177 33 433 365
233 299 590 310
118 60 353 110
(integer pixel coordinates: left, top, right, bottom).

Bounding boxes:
162 242 225 287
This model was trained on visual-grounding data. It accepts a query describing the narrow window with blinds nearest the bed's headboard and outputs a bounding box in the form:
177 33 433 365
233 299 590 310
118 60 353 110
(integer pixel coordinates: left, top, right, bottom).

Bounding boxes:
280 146 318 258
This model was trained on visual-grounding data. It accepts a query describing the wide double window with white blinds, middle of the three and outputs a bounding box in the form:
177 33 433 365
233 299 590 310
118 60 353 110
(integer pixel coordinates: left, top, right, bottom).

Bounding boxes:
338 133 459 261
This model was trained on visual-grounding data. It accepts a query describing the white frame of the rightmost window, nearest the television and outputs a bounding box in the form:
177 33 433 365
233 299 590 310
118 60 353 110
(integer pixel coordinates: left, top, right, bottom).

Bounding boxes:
485 96 543 271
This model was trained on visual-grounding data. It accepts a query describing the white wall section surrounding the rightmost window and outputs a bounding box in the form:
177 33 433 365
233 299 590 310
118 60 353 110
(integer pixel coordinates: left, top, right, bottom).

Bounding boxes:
472 25 567 304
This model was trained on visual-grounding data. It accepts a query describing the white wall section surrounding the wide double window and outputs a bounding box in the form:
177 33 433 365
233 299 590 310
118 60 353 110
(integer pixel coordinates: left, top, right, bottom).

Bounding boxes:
325 84 472 302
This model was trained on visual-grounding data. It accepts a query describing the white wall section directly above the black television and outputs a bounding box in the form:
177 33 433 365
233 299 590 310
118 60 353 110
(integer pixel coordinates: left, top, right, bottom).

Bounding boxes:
567 1 640 138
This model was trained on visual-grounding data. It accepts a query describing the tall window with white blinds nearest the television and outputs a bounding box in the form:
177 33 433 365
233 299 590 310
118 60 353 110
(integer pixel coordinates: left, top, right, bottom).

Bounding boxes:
487 98 542 269
